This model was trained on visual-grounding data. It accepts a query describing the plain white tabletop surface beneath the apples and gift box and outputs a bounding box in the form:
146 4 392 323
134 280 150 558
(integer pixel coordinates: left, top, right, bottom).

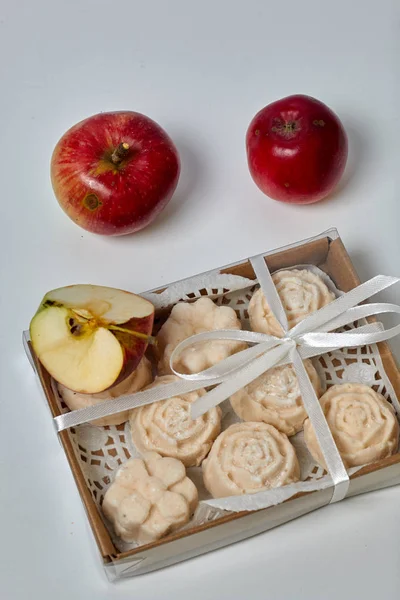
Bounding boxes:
0 0 400 600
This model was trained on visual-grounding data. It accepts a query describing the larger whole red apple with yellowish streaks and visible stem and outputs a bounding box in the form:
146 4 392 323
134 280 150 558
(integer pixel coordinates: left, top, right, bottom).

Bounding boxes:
51 111 180 235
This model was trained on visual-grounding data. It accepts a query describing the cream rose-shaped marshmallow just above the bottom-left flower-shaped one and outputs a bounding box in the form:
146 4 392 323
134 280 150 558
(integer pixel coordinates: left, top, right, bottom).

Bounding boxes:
129 375 221 467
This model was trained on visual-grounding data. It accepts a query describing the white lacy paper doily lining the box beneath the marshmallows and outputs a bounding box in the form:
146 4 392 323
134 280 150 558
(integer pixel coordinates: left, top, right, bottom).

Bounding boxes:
53 265 400 552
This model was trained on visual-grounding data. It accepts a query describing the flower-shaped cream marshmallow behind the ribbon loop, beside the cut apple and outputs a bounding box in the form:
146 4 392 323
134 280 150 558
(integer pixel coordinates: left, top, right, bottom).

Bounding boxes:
157 298 247 375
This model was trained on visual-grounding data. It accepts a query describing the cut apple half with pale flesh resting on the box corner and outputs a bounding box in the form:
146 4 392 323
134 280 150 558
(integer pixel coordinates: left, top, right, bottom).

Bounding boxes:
30 285 154 394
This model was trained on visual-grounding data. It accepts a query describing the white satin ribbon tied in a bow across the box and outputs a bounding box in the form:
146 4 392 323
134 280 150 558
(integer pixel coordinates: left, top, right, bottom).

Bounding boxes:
54 256 400 502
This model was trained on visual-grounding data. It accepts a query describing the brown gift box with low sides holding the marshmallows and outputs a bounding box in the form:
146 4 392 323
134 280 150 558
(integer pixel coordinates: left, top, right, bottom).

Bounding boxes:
26 229 400 580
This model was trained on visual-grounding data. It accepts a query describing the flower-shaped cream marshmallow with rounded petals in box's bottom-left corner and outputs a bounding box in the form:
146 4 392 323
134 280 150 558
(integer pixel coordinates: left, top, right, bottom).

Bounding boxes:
102 452 198 544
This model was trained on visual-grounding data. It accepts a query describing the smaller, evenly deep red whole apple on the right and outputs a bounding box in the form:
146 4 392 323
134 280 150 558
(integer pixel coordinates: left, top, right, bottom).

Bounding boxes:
246 95 348 204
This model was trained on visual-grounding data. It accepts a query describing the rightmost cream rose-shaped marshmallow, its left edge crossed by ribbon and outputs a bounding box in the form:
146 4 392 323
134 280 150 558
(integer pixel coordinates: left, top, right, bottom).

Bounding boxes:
304 383 399 469
